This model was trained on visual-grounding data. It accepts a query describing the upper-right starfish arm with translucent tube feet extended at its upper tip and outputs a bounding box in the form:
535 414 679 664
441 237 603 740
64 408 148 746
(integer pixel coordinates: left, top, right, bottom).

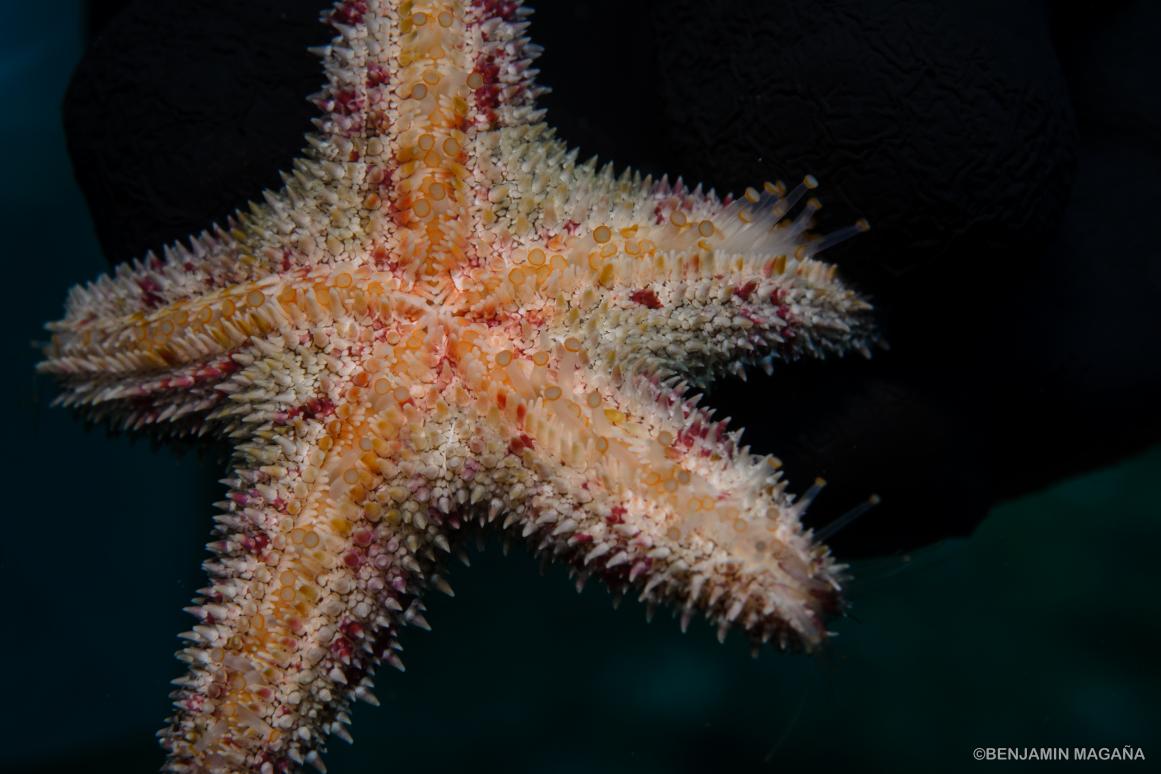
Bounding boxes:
483 134 875 383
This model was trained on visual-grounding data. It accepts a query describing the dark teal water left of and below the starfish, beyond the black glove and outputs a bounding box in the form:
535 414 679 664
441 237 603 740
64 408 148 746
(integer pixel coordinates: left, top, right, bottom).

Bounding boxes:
0 2 1161 774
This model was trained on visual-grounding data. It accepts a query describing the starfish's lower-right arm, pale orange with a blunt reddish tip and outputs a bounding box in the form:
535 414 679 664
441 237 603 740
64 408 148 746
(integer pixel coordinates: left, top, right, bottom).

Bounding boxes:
471 339 841 649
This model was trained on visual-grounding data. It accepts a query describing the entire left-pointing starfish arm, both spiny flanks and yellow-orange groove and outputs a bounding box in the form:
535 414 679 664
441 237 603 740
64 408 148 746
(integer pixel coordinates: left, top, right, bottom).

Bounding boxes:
38 195 348 424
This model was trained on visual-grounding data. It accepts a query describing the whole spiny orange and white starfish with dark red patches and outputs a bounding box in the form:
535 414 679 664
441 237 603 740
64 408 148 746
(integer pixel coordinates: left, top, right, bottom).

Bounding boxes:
41 0 874 773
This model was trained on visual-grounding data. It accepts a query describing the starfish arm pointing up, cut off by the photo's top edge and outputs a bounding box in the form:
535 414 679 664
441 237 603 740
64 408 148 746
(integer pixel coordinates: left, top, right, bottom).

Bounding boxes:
299 0 547 288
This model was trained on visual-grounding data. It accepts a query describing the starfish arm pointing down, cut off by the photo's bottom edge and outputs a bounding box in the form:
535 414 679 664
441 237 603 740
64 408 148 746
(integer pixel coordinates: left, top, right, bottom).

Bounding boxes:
160 350 461 772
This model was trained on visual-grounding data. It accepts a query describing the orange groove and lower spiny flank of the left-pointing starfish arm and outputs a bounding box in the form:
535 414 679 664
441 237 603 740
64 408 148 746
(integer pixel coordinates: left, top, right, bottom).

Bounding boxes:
39 258 422 433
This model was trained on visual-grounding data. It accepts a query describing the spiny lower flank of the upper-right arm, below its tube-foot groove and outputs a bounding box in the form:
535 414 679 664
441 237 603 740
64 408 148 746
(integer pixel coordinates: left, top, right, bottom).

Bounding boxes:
577 244 875 385
